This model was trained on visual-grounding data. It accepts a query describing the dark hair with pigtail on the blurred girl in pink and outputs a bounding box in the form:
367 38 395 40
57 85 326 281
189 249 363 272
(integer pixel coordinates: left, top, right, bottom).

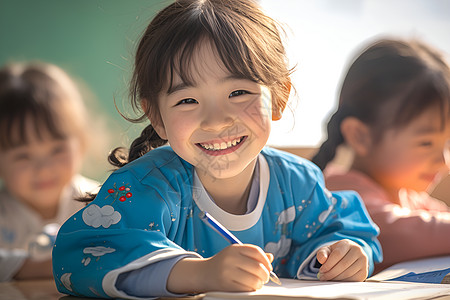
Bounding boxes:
312 39 450 170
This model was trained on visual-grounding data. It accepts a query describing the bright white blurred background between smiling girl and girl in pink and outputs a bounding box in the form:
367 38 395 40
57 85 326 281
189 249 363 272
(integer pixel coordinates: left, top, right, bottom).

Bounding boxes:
260 0 450 147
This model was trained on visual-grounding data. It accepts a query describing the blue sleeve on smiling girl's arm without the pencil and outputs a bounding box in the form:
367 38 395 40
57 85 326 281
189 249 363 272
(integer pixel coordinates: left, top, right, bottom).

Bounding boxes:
289 185 382 277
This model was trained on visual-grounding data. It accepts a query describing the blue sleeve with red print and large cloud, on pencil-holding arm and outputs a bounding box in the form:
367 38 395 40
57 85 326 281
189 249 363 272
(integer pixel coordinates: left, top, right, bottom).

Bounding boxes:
53 171 199 298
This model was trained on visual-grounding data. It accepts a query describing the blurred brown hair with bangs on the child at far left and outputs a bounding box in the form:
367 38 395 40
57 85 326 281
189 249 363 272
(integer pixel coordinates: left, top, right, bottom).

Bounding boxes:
0 62 86 150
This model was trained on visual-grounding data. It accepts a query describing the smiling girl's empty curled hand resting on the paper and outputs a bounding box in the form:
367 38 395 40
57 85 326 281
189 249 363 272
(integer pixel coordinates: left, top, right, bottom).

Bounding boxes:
316 240 369 281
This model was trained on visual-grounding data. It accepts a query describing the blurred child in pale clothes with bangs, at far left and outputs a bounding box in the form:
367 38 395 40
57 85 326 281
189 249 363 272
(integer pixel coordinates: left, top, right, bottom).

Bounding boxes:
0 63 98 281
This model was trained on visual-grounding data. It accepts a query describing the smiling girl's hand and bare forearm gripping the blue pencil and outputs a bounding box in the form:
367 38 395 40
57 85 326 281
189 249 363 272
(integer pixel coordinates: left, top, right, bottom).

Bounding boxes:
167 244 273 293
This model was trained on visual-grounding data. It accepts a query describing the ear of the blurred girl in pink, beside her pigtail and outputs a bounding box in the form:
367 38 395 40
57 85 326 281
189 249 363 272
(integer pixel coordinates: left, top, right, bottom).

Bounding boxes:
341 117 372 156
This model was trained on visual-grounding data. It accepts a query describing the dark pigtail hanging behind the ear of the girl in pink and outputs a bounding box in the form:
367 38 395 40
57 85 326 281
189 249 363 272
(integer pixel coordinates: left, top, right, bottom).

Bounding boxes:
311 110 344 171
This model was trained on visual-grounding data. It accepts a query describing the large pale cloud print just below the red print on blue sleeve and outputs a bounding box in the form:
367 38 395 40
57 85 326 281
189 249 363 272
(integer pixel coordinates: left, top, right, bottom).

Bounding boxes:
83 204 122 228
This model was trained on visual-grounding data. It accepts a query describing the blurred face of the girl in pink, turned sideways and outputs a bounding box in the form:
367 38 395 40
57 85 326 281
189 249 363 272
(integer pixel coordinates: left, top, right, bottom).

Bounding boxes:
366 108 450 197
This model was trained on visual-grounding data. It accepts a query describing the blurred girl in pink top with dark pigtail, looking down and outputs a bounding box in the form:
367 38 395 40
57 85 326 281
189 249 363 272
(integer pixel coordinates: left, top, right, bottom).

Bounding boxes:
312 39 450 270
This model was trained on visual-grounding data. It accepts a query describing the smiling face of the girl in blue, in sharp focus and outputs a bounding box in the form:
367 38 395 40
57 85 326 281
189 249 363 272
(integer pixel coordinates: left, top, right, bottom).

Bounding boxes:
153 43 272 179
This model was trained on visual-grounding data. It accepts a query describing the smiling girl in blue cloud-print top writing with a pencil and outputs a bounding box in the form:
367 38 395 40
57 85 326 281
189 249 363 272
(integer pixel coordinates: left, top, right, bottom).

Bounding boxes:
53 0 381 299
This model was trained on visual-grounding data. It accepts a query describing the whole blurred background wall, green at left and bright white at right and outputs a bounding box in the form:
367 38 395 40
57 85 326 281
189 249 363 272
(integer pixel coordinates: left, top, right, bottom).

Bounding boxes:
0 0 450 180
